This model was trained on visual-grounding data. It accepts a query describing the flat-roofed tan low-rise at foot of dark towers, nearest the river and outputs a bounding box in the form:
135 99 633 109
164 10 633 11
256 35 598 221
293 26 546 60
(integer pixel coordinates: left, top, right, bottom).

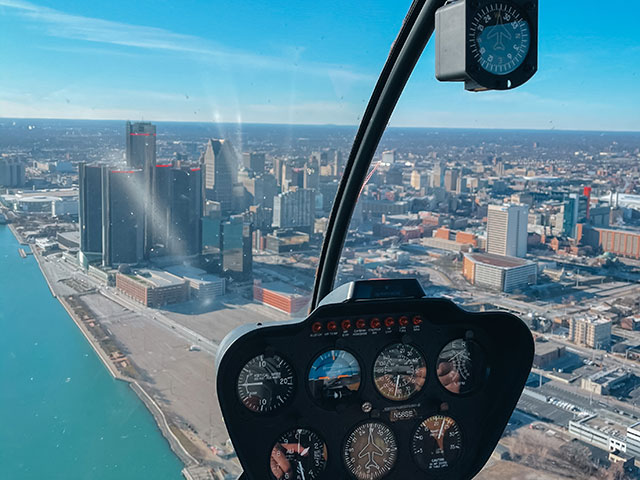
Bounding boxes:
116 269 189 307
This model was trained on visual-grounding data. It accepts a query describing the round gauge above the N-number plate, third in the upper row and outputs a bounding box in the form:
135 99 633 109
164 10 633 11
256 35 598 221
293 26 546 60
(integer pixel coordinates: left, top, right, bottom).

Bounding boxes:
373 343 427 402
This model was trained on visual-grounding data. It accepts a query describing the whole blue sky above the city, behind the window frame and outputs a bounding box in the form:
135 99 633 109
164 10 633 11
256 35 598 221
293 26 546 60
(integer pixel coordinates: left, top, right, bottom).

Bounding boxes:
0 0 640 131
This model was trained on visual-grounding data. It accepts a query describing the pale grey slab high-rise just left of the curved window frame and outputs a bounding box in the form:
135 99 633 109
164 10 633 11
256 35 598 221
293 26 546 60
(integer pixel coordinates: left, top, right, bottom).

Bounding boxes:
273 188 315 233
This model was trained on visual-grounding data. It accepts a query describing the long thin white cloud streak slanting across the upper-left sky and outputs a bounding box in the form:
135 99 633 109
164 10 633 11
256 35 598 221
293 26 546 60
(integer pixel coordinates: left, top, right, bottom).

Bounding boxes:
0 0 375 83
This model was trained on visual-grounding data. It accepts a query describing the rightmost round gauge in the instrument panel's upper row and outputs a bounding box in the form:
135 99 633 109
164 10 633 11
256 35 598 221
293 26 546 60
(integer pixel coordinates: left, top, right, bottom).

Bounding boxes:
436 339 488 394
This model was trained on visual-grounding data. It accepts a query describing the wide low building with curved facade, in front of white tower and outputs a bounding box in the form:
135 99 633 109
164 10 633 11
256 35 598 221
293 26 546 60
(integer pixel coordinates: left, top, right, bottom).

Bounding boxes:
462 253 538 293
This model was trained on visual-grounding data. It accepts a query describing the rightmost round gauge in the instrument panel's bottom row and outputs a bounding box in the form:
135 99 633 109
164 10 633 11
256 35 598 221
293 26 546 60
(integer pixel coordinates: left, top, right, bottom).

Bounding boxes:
411 415 462 472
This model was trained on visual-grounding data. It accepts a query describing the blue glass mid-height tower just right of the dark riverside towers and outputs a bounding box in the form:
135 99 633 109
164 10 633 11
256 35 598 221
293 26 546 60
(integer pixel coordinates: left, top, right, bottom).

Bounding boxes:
221 215 253 279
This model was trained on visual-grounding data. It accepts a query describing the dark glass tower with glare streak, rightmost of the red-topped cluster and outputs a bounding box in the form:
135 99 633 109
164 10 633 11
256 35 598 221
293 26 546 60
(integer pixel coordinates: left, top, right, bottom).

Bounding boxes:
147 164 204 256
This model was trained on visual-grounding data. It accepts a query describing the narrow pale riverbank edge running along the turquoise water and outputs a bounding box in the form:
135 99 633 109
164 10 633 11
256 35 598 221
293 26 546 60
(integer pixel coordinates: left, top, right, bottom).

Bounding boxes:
15 230 201 479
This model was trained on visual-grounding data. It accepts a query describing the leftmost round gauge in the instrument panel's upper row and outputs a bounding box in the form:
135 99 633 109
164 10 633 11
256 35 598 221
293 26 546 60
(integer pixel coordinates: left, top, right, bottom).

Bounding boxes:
236 355 294 413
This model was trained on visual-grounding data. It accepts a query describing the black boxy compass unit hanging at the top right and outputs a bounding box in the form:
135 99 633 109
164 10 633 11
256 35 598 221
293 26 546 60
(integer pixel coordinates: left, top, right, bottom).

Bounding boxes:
436 0 538 92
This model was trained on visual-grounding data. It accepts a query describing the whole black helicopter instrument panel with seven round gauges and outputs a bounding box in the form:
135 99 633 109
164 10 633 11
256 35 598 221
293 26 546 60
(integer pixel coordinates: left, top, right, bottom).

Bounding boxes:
216 285 534 480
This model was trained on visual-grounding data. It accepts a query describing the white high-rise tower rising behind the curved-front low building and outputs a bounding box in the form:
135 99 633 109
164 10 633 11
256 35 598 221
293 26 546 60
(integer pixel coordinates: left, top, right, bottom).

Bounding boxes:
487 205 529 258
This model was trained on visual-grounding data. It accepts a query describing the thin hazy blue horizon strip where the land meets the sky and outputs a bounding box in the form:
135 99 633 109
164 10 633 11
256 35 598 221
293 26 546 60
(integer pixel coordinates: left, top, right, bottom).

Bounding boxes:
0 116 640 134
